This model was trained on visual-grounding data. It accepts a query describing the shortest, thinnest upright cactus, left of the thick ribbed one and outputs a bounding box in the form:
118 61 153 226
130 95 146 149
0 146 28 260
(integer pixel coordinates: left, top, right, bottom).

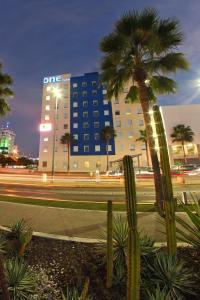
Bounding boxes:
106 200 113 288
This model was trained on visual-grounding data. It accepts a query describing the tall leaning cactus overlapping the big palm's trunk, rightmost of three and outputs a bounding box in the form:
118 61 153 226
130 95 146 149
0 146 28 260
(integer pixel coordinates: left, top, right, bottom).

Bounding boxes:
153 105 177 255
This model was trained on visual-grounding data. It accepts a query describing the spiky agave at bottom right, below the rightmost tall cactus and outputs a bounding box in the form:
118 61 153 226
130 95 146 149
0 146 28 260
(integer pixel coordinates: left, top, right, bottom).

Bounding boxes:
148 251 194 300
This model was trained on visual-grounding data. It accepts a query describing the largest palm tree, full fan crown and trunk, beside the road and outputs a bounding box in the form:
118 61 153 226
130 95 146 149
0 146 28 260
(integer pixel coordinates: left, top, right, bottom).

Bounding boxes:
100 9 188 206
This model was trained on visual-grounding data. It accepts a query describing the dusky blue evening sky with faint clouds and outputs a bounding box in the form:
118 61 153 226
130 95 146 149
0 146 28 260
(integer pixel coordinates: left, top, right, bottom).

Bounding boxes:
0 0 200 156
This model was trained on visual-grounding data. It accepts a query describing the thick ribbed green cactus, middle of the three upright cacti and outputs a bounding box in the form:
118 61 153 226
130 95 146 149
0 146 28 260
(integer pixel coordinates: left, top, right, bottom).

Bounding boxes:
123 155 140 300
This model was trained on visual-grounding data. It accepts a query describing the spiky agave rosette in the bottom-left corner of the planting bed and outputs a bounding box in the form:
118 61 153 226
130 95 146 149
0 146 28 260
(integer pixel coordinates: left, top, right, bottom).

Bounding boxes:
6 259 36 300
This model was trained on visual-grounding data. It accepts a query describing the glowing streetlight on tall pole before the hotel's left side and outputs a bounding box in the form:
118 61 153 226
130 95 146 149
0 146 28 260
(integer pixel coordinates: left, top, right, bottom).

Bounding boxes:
51 87 62 180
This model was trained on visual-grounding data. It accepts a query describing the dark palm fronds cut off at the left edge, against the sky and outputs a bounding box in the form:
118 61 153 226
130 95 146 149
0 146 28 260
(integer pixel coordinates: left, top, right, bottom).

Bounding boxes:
0 63 13 116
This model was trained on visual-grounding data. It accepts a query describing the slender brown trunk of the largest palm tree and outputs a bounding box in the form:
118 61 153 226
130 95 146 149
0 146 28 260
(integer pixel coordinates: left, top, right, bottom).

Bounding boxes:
138 82 163 214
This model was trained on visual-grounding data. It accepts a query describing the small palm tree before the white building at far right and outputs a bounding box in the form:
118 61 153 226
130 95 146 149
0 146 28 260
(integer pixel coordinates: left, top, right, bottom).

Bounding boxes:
171 124 194 164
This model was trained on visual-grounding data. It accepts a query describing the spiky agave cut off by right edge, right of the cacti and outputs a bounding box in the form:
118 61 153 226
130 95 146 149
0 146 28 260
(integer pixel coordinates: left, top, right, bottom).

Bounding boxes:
176 194 200 248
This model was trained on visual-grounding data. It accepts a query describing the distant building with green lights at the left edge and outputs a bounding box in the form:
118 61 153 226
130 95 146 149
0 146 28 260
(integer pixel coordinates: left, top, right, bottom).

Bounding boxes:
0 125 16 155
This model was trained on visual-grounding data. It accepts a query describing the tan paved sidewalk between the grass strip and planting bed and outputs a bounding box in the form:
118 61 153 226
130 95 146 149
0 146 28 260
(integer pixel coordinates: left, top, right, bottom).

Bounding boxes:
0 202 184 242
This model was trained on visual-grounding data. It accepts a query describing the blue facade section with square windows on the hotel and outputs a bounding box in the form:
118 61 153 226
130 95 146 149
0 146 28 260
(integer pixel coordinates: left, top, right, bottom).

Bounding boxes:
70 72 115 156
